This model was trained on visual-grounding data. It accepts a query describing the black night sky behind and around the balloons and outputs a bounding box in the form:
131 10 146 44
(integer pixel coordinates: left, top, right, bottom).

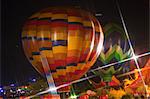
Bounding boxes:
1 0 149 85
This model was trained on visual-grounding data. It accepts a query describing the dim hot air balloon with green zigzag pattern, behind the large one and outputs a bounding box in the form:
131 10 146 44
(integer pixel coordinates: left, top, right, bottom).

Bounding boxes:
86 23 131 85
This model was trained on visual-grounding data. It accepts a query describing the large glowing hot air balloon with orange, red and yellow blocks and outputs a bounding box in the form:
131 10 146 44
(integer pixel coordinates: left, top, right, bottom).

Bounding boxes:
22 7 103 92
